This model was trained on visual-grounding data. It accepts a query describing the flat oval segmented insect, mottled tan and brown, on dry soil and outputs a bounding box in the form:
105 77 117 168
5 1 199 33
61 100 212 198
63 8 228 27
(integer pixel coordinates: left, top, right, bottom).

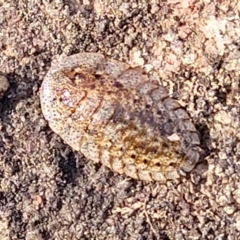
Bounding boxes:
40 53 202 181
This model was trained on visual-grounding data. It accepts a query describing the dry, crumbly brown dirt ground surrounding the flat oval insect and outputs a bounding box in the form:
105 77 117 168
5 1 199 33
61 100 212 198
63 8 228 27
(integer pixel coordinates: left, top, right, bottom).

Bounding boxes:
0 0 240 240
